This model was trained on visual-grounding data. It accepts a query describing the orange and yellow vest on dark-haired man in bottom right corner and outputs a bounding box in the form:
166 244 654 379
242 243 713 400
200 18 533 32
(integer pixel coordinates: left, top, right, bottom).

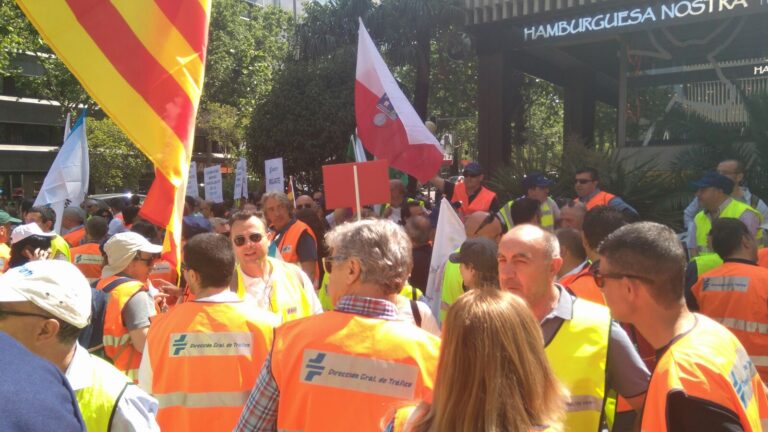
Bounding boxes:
642 314 768 432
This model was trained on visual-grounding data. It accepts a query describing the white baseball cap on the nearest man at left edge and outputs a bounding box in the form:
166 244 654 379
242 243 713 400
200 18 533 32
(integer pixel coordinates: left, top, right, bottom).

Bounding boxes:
0 260 91 328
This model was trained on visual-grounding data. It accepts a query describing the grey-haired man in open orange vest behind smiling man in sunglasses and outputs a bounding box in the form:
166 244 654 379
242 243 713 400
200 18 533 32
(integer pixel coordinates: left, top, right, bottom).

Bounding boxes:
261 192 320 288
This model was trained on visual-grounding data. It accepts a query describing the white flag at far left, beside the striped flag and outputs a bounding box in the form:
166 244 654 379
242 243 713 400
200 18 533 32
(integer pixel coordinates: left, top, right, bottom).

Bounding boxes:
34 112 89 233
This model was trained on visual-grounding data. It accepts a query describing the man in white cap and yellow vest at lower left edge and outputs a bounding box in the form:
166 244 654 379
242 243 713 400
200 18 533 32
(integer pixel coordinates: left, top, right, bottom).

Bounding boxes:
0 260 160 432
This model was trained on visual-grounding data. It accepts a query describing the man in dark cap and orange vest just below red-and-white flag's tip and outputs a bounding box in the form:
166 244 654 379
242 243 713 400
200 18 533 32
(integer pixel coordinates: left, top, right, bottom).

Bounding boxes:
430 162 499 220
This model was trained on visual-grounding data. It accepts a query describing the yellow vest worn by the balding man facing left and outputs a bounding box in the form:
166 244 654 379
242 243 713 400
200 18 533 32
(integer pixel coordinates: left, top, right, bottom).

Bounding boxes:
545 292 611 432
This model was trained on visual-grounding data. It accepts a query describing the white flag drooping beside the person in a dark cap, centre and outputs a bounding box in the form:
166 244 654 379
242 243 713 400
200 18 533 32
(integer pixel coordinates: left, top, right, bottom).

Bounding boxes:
424 198 467 317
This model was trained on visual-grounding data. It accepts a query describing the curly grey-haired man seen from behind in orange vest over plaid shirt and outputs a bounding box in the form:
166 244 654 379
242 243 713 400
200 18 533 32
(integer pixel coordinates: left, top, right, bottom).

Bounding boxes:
235 220 440 431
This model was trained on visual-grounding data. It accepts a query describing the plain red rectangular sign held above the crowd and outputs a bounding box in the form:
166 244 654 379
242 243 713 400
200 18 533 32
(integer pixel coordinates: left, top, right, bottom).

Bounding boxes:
323 160 390 209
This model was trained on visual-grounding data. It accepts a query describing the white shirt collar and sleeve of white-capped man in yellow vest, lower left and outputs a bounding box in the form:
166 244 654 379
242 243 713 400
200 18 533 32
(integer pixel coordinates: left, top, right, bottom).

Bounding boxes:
67 344 160 432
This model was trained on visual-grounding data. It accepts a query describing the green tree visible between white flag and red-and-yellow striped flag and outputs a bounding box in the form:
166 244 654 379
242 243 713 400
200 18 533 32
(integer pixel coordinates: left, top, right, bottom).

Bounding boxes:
86 118 152 192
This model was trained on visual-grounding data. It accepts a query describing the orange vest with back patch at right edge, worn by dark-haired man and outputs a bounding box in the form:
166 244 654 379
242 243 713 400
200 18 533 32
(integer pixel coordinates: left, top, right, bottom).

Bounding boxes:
691 262 768 380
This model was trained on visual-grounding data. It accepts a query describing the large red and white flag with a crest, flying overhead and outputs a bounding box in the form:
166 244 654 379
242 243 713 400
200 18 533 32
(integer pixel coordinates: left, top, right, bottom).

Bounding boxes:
355 20 443 183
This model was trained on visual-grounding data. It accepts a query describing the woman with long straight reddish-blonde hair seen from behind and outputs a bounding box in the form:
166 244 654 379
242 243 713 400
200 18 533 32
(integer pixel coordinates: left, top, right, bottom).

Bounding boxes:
386 289 567 432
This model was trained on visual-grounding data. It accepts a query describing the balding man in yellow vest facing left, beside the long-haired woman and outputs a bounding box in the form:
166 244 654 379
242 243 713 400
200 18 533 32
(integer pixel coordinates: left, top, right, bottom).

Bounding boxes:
497 225 651 432
